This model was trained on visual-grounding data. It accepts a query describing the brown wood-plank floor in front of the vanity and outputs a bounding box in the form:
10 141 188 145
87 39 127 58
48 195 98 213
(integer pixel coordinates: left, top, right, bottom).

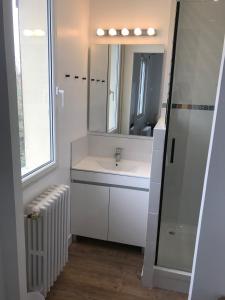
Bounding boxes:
47 238 187 300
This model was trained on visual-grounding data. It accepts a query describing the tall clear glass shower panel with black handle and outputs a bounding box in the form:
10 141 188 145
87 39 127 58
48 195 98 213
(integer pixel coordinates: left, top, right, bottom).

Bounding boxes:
157 0 225 272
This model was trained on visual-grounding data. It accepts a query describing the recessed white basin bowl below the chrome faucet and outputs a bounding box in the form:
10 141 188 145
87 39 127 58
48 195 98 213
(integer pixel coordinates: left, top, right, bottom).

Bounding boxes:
97 158 138 173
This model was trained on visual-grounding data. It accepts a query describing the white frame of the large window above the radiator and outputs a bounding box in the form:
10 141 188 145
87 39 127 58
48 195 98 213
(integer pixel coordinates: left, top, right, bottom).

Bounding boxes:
14 0 57 186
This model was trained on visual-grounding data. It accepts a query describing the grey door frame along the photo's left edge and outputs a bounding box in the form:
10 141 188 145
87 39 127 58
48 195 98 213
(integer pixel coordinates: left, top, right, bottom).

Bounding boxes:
0 0 27 300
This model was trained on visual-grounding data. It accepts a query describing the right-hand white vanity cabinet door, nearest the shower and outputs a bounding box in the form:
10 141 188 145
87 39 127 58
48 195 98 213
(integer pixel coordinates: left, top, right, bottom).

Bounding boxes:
108 188 149 247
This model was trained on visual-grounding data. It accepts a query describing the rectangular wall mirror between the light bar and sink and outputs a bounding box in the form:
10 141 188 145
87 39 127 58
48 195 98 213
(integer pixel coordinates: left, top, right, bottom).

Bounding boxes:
88 44 164 137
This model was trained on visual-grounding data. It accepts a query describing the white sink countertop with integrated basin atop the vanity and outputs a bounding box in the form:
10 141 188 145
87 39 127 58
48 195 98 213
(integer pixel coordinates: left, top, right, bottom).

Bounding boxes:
72 156 151 178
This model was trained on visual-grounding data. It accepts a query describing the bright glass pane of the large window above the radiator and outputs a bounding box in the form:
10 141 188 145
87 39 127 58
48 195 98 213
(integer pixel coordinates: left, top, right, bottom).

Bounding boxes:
12 0 55 178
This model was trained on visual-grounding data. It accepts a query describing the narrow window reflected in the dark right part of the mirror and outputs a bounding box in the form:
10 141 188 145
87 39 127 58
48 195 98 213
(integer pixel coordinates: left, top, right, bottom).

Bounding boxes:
137 57 146 116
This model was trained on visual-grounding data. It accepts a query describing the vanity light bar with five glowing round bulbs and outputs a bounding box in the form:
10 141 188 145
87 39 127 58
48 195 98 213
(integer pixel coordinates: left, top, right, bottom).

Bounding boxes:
96 27 157 37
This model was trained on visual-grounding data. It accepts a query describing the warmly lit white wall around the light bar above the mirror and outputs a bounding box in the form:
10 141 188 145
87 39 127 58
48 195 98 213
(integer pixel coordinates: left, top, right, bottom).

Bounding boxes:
90 0 176 101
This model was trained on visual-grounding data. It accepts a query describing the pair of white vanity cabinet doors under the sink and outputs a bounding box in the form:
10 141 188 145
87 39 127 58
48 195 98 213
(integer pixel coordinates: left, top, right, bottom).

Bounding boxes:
71 182 149 247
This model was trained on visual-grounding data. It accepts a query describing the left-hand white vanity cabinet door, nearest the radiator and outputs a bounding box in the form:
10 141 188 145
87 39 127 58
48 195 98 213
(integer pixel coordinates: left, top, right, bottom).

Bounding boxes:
71 183 109 240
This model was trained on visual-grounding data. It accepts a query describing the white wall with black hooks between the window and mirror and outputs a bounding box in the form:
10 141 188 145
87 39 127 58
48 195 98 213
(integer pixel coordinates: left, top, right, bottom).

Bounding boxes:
23 0 89 203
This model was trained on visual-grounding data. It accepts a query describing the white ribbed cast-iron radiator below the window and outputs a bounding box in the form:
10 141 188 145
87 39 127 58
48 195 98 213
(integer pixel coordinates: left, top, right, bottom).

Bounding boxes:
25 185 70 296
